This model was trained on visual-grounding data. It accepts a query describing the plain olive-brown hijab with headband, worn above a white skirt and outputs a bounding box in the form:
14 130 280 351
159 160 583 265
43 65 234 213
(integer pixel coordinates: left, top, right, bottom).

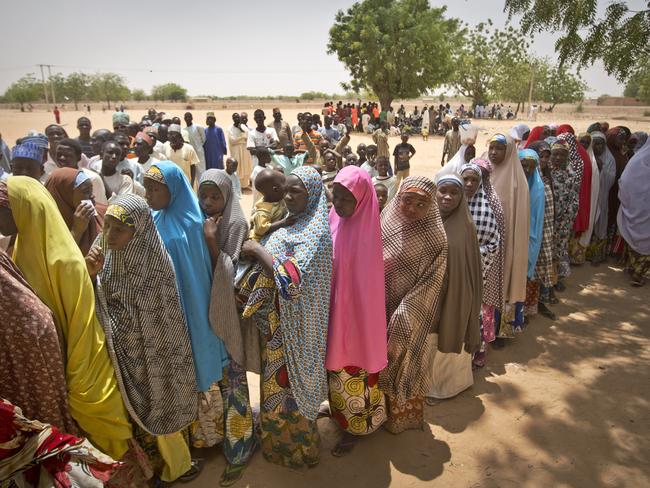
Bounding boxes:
432 175 483 352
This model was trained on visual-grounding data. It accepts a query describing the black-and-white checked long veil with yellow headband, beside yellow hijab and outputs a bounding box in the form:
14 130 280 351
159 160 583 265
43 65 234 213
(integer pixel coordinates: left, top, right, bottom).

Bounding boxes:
97 195 197 435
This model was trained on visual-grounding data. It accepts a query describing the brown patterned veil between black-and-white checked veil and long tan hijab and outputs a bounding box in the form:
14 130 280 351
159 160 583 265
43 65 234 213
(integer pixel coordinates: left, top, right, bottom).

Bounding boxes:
481 177 506 310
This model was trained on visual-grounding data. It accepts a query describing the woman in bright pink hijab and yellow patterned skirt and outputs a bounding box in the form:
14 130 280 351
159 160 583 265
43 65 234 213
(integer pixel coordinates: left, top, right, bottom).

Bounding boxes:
325 166 388 456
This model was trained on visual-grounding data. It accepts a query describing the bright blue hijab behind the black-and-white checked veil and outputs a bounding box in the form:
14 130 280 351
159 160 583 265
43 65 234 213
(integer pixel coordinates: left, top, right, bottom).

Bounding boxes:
147 161 228 391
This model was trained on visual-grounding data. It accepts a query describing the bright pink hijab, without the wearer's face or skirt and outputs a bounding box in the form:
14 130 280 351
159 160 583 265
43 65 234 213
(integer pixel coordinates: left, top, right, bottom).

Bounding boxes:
325 166 388 373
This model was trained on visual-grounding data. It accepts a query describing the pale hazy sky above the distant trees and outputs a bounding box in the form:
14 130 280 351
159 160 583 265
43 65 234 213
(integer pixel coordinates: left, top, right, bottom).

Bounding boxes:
0 0 644 96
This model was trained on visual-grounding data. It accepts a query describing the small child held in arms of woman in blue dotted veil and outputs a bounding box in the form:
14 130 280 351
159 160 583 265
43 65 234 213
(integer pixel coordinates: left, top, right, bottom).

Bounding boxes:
248 169 291 242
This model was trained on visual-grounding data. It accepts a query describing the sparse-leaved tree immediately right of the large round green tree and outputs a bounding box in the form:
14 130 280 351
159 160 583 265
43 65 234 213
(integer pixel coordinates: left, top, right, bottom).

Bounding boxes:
450 20 528 105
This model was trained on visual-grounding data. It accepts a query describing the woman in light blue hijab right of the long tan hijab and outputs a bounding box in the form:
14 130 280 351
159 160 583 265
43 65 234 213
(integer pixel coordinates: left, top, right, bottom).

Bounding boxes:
519 149 545 328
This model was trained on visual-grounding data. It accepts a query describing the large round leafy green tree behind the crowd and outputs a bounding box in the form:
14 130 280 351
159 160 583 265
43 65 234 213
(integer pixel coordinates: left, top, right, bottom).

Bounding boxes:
327 0 459 110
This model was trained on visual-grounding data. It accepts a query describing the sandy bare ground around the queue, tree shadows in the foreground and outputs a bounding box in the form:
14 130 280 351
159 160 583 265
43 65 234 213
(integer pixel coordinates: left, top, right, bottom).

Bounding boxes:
0 103 650 488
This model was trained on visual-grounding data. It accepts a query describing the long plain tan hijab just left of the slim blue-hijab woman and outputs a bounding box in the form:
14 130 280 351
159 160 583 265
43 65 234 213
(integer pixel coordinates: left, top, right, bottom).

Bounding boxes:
486 135 530 305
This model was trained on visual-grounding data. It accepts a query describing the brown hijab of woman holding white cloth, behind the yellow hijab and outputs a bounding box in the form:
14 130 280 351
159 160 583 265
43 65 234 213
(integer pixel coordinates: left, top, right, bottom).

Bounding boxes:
45 168 106 256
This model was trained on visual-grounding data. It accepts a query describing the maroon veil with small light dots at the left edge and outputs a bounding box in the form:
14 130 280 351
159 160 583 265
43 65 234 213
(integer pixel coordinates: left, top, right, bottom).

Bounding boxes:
0 250 77 434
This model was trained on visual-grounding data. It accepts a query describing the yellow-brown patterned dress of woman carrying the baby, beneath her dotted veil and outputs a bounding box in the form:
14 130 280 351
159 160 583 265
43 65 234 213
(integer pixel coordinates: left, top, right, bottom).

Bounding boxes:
241 272 320 468
